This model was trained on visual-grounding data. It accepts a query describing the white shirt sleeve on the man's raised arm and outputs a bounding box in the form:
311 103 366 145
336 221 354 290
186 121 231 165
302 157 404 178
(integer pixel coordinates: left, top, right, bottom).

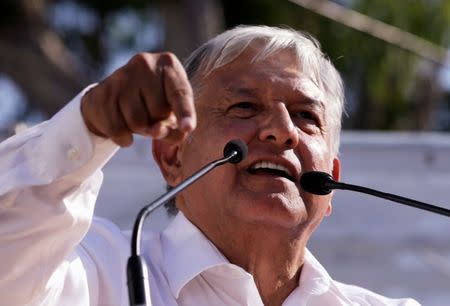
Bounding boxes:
0 87 118 305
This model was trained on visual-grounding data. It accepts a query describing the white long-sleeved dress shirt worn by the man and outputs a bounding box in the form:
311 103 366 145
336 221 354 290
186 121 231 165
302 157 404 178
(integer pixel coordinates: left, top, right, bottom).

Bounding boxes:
0 88 419 306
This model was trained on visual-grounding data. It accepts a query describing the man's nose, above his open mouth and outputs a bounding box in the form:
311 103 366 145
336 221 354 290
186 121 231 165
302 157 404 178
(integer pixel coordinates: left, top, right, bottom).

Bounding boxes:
259 101 299 149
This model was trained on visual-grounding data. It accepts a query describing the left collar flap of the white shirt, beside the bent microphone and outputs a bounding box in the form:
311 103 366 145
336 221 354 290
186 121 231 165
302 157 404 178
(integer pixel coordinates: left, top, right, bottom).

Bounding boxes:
161 212 229 298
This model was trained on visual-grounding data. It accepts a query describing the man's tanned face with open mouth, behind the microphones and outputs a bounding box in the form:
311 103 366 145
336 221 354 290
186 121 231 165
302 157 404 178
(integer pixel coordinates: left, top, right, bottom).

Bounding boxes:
174 50 339 236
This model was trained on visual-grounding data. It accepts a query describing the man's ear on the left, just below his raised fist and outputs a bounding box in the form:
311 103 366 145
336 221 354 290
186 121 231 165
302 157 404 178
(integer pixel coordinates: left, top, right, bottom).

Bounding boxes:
152 139 181 186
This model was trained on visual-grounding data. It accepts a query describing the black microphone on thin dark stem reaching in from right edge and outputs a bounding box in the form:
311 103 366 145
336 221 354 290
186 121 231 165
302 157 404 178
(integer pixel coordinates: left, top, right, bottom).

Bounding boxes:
300 171 450 217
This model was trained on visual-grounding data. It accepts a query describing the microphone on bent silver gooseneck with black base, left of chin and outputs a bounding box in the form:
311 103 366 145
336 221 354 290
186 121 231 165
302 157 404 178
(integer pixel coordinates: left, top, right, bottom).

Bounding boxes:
127 139 248 306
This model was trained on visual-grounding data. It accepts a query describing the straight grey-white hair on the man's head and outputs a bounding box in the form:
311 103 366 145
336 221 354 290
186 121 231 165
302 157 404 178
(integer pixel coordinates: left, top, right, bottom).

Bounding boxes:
185 26 344 155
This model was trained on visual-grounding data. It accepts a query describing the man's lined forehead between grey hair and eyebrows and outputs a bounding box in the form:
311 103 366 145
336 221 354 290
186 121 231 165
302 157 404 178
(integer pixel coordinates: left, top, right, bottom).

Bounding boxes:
200 49 324 103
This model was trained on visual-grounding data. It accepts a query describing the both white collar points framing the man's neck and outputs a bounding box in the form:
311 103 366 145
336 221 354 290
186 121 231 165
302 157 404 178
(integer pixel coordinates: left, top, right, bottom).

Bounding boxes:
161 212 343 306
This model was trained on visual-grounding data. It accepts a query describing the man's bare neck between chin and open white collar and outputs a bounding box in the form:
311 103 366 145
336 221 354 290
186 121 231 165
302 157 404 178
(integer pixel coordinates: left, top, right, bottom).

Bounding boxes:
213 226 306 306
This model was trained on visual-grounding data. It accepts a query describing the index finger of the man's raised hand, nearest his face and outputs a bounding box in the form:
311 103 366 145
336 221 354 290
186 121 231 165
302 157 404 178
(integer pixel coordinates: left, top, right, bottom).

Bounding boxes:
163 61 197 132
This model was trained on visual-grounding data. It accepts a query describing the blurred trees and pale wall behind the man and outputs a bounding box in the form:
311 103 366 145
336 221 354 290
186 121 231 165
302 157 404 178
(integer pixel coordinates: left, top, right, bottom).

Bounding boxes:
0 0 450 306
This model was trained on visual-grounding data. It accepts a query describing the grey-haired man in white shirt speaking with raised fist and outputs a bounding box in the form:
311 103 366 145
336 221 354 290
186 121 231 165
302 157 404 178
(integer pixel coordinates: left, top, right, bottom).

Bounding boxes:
0 27 418 306
